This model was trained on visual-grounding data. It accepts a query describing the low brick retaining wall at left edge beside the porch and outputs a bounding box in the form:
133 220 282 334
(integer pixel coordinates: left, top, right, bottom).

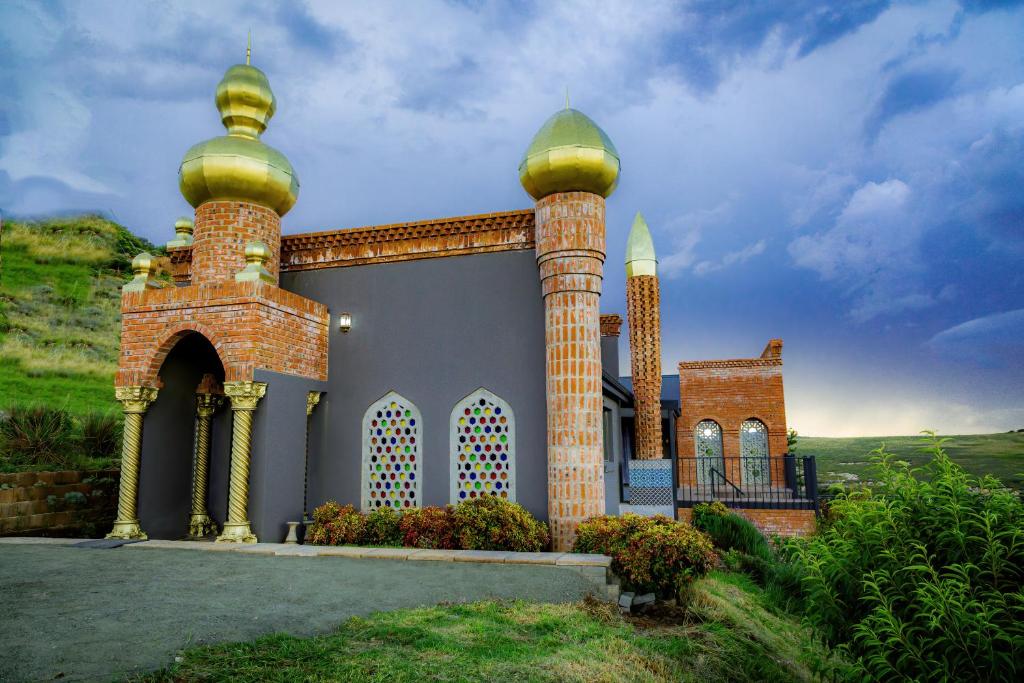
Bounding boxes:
0 470 120 537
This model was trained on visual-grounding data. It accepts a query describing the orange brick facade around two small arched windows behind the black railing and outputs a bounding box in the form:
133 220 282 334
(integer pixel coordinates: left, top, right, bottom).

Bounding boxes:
676 339 787 485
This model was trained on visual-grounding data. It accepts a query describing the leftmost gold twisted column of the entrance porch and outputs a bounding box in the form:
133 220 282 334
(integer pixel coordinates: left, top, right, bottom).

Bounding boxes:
106 386 157 541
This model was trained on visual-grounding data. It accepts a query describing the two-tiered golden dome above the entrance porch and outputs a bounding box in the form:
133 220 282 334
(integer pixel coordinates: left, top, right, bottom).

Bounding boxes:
178 58 299 216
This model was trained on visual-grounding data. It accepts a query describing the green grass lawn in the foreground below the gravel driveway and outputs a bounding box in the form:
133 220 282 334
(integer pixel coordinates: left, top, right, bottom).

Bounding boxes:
144 572 825 682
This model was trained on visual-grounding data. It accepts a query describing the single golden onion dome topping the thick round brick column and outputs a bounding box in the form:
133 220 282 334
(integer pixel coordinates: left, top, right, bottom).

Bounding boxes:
519 106 620 200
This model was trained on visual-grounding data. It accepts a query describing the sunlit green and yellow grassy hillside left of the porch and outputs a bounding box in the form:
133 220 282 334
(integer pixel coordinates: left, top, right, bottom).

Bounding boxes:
0 216 154 414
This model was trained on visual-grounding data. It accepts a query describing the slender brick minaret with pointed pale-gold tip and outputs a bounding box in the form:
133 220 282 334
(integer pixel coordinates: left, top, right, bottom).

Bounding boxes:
626 211 663 460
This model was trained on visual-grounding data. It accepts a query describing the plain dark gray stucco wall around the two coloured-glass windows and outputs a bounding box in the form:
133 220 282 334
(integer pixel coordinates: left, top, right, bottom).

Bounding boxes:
282 250 548 519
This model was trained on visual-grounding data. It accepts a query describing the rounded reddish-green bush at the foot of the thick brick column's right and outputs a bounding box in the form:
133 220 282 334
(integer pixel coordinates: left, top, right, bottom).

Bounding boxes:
572 514 717 597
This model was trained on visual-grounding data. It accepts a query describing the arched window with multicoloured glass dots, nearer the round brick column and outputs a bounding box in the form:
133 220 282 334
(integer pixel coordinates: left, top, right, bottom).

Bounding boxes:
450 388 515 503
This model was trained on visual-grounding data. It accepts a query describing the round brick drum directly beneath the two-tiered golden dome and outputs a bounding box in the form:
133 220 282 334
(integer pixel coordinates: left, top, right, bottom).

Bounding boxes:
191 200 281 285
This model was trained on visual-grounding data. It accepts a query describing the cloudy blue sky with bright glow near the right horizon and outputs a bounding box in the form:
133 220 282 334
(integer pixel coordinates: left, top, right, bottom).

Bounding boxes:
0 0 1024 435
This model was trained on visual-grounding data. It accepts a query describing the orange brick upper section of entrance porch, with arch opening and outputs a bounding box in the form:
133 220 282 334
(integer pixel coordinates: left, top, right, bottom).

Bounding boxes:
117 281 330 386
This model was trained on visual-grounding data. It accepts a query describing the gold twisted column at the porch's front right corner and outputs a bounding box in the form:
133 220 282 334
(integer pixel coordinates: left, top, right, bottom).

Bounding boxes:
217 382 266 543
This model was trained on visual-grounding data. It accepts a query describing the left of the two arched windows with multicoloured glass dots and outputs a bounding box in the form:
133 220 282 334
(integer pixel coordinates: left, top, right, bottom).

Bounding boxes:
361 391 423 511
